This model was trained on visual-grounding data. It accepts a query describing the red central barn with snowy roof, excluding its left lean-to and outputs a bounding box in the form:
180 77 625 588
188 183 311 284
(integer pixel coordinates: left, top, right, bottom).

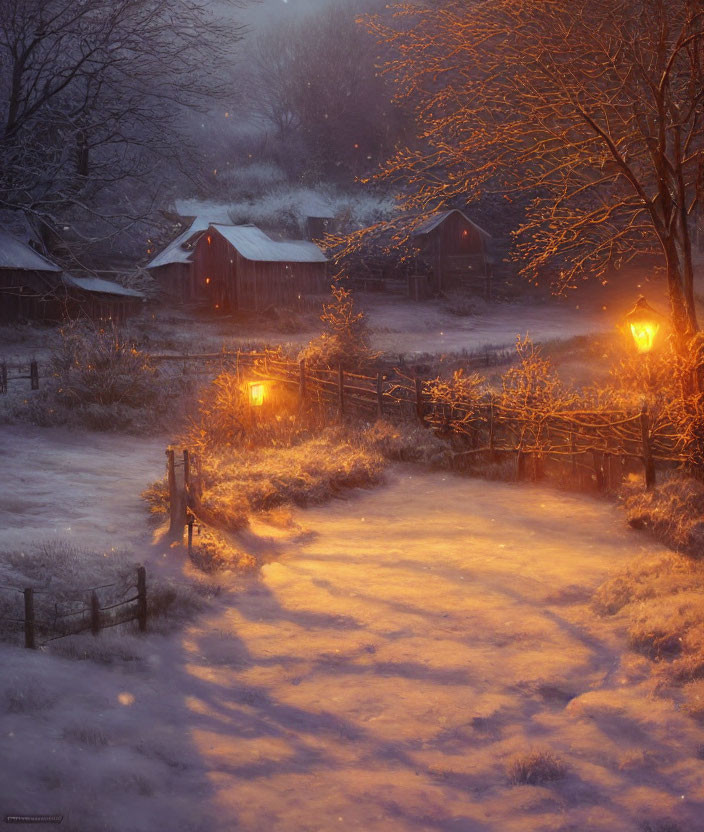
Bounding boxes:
193 224 327 312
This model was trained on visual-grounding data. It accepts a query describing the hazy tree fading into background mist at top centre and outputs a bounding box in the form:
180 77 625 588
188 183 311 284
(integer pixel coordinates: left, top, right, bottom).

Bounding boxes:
249 0 403 179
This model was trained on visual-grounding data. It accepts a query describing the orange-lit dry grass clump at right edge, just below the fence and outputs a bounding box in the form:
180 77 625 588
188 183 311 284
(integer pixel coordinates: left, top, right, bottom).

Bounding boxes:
626 474 704 557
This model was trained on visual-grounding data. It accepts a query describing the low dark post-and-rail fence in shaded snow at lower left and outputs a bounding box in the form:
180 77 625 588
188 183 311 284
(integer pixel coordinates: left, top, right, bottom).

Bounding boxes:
0 566 147 649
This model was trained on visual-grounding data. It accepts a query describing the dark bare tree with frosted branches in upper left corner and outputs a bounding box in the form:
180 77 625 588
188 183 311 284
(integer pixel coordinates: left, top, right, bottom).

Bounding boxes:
0 0 248 239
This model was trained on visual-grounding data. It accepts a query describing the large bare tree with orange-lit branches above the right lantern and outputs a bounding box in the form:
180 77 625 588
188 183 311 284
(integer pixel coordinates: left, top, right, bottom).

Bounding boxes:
369 0 704 352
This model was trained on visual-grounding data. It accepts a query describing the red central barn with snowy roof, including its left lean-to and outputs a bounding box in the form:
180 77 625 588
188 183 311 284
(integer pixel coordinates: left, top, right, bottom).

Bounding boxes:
147 219 327 312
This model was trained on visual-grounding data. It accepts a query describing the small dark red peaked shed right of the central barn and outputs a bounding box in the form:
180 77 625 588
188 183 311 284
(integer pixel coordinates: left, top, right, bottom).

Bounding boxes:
411 209 491 298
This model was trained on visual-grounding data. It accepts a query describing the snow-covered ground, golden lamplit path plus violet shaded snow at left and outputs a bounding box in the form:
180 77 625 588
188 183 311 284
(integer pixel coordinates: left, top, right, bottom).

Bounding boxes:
0 429 704 832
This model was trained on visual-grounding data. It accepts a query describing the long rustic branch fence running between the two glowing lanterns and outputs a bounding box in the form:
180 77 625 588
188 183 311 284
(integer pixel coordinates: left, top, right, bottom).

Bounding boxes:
230 351 687 489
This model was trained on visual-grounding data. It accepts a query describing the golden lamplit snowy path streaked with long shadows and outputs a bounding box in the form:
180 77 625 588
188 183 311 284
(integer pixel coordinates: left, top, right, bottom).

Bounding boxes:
184 469 704 832
